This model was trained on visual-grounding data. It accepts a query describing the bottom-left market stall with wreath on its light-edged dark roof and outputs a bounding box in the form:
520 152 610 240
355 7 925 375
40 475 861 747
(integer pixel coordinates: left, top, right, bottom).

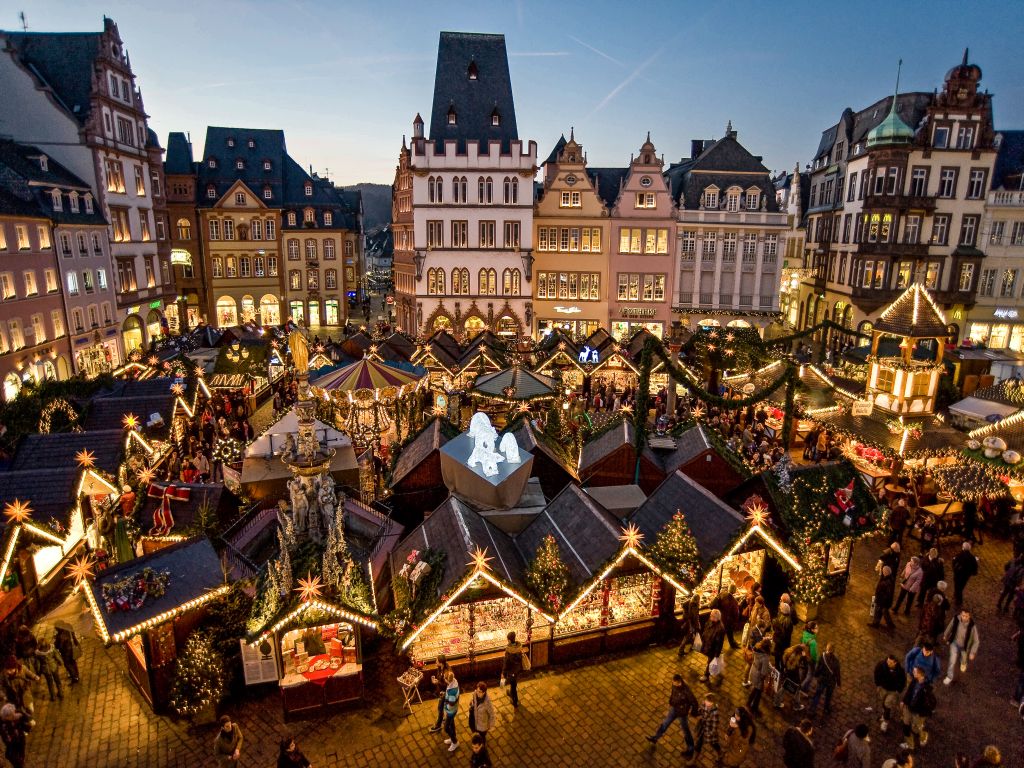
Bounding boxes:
78 538 228 712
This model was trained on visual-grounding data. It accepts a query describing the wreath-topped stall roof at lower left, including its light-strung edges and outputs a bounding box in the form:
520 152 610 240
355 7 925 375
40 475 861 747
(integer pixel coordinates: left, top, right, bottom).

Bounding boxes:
85 538 227 643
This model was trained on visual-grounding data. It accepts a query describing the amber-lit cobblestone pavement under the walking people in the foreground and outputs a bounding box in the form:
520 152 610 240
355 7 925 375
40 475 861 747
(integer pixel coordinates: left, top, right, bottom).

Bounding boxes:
29 539 1024 768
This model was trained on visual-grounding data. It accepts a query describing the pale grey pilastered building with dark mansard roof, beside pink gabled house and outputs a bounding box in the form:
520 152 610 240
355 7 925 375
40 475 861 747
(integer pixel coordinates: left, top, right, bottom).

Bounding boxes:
665 124 787 333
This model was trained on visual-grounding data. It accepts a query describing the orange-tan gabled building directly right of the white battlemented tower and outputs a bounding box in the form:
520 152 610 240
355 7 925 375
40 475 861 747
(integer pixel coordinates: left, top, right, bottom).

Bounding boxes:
534 131 617 338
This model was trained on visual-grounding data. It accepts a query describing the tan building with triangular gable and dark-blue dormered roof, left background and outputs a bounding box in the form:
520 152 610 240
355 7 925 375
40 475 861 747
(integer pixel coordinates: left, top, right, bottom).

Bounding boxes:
196 127 288 327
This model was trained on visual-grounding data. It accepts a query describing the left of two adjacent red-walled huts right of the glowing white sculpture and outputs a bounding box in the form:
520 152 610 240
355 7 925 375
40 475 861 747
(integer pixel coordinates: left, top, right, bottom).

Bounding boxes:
579 419 665 495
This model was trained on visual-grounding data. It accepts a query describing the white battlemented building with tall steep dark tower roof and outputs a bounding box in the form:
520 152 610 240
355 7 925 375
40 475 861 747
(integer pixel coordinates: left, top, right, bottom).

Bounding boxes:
394 32 537 337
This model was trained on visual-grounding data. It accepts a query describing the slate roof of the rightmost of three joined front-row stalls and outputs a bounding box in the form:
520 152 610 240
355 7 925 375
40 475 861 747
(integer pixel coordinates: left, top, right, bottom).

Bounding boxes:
630 470 746 567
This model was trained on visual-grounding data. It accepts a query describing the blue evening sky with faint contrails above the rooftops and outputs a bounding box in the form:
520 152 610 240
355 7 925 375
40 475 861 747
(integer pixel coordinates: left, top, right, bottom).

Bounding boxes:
8 0 1024 183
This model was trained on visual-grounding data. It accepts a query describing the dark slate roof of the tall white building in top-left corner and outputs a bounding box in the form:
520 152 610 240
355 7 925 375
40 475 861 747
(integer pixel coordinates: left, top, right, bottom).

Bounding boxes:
3 32 102 125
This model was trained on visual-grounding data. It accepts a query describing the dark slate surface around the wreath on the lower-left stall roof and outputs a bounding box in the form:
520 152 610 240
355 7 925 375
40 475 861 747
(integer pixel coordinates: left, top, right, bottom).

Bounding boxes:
89 538 224 635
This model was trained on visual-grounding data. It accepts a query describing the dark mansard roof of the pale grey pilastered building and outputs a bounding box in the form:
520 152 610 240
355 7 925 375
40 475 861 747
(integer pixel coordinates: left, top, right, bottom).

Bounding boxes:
665 134 778 211
